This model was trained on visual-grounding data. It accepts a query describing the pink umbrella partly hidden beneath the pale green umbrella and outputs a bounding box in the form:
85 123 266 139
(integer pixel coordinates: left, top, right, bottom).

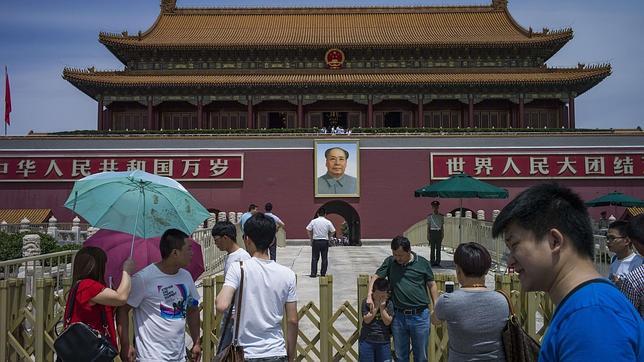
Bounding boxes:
83 229 204 288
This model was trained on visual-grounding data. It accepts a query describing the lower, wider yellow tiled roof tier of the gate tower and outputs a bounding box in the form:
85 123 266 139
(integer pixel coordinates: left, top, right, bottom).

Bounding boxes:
63 66 611 87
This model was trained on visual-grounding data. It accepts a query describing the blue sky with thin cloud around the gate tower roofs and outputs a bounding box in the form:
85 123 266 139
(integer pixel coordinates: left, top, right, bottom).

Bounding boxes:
0 0 644 135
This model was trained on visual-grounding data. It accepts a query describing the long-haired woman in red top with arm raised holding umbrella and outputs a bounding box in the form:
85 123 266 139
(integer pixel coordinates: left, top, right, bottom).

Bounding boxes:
55 246 135 362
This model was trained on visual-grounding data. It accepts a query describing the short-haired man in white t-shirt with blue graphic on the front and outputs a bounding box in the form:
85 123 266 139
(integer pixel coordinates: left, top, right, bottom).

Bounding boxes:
117 229 201 362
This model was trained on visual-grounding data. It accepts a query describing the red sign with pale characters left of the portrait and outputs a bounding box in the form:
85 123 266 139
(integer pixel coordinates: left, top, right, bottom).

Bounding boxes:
0 150 244 182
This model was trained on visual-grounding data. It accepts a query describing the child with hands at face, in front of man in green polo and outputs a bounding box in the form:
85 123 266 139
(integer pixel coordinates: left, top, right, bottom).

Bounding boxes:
358 278 394 362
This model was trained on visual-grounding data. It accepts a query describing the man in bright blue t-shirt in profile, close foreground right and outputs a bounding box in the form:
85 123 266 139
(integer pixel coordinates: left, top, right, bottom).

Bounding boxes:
492 183 644 362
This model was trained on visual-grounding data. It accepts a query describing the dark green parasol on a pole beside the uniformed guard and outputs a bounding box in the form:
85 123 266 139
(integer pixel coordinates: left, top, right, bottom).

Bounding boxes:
414 173 508 243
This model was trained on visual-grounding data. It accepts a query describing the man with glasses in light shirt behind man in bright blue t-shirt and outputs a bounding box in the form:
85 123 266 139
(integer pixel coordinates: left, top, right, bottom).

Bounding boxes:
606 220 643 284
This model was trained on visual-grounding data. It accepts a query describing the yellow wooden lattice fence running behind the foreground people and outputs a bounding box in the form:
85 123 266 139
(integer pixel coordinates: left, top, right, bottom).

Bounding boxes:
0 274 554 362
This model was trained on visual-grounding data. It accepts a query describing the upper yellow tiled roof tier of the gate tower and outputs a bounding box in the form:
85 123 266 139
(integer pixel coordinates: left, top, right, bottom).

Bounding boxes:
100 6 572 48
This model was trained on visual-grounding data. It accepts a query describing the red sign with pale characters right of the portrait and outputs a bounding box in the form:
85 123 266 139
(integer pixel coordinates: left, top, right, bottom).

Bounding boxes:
430 151 644 180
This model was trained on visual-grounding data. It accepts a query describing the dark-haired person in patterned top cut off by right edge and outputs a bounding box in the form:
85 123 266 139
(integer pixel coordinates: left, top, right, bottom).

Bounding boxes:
618 214 644 318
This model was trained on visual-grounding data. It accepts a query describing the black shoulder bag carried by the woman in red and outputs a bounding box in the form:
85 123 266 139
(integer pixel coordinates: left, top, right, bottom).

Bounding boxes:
54 281 117 362
